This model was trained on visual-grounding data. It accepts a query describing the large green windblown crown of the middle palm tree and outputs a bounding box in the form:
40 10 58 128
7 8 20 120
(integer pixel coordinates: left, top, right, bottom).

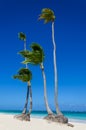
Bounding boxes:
22 43 44 65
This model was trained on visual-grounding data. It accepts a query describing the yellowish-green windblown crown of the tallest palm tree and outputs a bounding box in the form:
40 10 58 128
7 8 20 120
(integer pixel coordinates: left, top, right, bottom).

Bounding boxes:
39 8 55 23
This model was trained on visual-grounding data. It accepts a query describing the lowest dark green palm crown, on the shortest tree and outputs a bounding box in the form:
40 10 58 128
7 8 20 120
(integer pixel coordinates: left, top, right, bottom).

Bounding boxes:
13 68 32 82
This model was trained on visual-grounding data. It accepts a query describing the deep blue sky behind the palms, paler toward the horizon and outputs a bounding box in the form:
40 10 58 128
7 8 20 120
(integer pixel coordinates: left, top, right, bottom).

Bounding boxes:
0 0 86 110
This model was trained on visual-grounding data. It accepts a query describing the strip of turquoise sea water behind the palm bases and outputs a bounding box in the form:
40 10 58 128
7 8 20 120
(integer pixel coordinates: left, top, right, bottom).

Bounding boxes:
0 110 86 121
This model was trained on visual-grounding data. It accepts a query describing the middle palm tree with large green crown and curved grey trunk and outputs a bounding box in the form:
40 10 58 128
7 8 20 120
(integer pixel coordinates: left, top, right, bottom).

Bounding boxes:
20 43 53 116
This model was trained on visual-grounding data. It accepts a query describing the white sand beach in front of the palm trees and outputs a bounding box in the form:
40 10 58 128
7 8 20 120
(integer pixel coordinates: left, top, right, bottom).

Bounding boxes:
0 114 86 130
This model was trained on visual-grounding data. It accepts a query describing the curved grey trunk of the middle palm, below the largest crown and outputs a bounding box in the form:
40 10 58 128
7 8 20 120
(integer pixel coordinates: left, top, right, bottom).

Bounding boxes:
40 63 53 115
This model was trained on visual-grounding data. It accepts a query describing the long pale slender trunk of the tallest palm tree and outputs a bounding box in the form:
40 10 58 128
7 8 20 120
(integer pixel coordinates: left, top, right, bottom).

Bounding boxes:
52 22 63 115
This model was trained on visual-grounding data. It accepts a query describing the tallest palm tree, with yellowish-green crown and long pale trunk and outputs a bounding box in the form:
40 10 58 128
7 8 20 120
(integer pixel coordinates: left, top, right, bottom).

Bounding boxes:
39 8 63 115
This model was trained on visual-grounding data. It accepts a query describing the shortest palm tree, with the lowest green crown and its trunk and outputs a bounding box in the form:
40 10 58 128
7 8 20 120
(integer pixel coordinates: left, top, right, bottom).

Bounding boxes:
13 68 32 121
